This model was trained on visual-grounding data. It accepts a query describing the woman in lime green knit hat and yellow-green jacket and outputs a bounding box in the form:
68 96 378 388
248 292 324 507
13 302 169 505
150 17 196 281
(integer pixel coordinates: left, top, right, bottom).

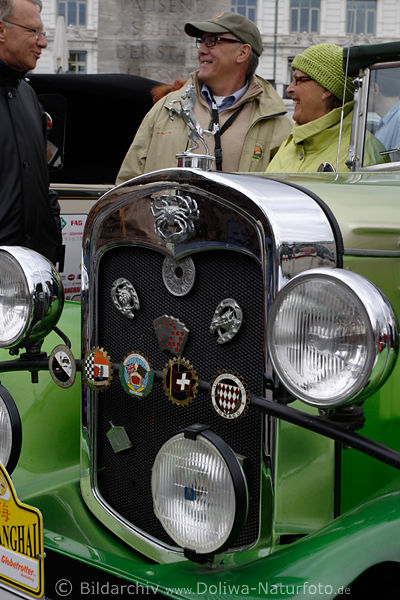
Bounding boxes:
267 44 383 173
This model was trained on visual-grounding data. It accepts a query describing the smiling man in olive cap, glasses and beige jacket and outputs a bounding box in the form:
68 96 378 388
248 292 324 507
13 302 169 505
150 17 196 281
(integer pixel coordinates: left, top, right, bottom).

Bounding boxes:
117 12 291 183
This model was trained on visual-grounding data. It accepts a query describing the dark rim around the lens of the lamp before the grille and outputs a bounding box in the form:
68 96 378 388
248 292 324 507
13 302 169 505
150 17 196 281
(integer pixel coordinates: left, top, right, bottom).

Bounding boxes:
152 424 249 562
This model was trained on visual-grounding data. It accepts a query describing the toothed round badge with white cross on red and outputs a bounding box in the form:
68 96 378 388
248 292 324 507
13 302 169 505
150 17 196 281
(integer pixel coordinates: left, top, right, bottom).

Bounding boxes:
163 358 199 406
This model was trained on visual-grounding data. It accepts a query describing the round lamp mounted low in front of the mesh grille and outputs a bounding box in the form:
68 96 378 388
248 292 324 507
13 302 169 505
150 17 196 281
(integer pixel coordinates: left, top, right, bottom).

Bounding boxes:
151 428 248 554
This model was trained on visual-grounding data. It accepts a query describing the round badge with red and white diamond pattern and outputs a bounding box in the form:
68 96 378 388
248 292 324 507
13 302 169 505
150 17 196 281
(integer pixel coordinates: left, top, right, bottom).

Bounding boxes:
211 373 249 419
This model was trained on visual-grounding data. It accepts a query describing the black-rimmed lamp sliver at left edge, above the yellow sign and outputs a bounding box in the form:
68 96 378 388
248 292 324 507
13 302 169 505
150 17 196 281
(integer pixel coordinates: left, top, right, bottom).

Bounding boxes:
0 385 22 475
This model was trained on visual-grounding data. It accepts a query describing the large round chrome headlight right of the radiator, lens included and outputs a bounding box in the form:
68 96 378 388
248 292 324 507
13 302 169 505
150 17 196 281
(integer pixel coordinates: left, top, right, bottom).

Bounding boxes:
267 269 398 407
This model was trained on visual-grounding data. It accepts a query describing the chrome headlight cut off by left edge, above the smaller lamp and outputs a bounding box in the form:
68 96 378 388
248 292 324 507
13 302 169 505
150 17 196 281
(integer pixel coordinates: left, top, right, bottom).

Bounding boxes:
0 246 64 348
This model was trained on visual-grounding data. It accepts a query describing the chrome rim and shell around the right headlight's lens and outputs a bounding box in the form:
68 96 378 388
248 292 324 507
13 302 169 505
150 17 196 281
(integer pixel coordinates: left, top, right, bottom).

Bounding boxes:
267 268 398 409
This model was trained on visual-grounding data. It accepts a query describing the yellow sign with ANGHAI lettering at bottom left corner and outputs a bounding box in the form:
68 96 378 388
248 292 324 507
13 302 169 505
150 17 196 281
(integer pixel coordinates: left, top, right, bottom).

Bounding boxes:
0 463 44 598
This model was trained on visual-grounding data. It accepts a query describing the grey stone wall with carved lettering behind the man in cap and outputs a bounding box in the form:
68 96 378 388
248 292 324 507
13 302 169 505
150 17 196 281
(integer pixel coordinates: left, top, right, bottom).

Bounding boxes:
98 0 231 78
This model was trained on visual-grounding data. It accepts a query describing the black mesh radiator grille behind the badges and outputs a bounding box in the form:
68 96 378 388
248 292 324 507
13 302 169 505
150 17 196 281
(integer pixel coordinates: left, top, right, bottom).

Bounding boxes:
96 246 264 546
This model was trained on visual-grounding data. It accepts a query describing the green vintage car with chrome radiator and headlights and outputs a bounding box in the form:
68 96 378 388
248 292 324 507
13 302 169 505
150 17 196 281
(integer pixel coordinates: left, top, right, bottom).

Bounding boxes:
0 43 400 600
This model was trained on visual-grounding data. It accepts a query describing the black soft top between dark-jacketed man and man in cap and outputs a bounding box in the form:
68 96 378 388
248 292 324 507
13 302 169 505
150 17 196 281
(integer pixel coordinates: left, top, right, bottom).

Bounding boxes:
29 74 159 183
